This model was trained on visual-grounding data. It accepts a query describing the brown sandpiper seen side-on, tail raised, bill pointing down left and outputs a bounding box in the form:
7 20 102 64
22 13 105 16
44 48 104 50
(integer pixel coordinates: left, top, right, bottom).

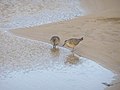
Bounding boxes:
63 37 83 52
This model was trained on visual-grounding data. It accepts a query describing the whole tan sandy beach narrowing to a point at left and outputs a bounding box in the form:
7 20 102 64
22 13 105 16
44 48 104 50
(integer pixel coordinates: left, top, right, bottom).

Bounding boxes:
0 0 120 90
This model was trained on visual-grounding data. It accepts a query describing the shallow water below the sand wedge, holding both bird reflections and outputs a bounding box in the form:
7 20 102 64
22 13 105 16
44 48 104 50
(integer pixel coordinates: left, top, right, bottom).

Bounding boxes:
0 31 115 90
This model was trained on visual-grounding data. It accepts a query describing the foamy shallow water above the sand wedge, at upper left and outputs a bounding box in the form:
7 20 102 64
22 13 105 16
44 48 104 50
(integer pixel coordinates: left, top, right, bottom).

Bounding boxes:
0 0 83 29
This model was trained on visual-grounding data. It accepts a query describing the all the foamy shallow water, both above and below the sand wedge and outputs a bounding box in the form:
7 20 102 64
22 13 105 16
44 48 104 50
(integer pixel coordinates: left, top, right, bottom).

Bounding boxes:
0 0 115 90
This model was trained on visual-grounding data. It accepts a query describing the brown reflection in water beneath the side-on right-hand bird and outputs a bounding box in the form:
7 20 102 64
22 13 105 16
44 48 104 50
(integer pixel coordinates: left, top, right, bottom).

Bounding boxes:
65 53 79 65
